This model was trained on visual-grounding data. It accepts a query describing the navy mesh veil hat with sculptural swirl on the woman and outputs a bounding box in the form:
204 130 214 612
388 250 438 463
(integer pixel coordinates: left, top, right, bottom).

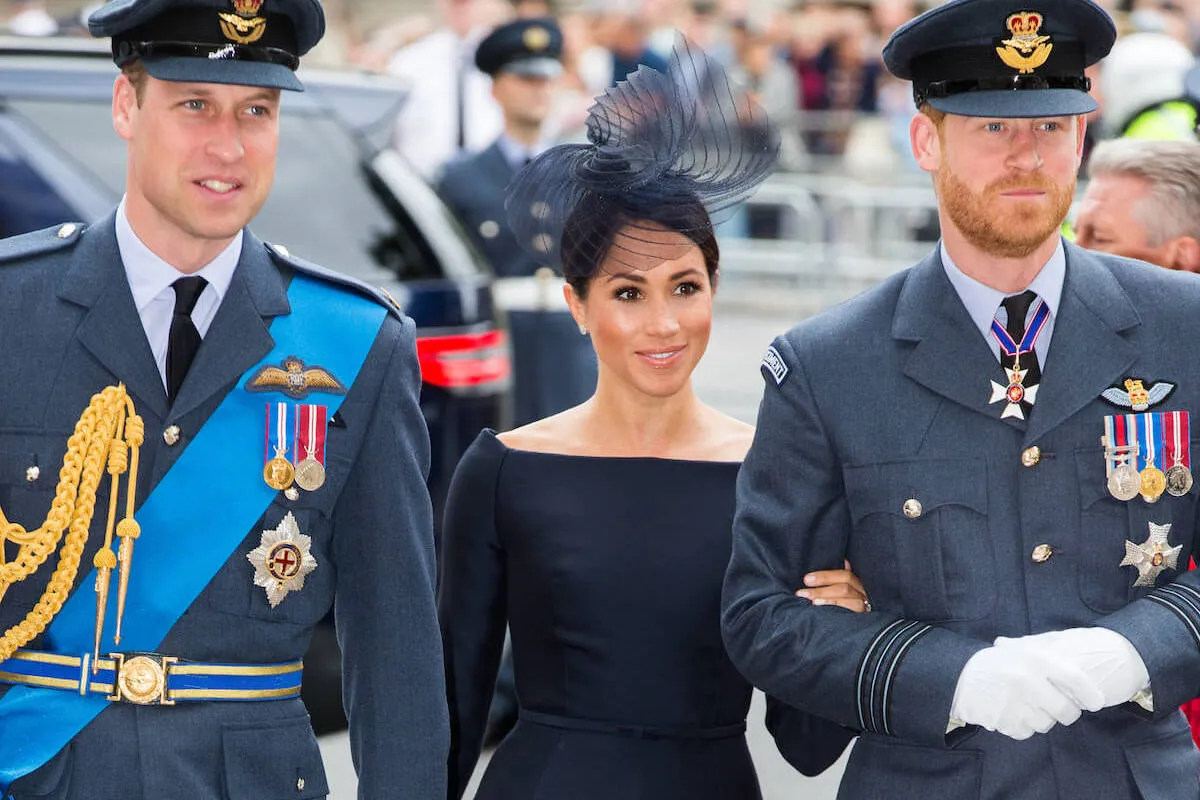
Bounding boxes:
505 36 779 277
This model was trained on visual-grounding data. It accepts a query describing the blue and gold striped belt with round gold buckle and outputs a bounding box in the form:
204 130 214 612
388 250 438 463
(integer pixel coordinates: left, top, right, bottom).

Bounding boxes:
0 650 304 705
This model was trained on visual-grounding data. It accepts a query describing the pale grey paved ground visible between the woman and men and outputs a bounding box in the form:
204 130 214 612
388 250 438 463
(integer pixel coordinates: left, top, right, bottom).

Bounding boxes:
322 290 845 800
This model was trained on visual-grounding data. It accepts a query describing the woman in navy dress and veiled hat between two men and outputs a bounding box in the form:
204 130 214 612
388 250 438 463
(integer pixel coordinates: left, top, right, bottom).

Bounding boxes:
439 38 865 800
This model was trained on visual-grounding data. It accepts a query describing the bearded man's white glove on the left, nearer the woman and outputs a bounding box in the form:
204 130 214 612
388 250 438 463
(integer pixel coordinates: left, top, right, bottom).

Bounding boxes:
950 646 1100 739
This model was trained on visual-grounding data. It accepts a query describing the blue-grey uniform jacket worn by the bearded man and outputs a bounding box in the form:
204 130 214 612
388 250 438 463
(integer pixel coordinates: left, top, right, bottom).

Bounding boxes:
722 245 1200 800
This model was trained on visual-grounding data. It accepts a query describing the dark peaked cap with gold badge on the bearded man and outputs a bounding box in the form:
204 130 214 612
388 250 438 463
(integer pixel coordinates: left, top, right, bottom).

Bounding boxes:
883 0 1116 118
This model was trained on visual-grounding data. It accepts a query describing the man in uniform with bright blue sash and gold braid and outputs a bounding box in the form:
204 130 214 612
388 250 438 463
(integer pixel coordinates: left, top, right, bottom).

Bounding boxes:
0 0 448 800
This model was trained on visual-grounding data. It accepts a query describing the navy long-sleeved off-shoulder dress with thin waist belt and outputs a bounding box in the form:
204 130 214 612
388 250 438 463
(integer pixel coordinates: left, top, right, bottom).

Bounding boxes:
439 431 853 800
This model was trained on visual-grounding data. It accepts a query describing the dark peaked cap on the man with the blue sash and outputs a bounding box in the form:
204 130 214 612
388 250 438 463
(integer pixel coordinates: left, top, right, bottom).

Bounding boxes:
88 0 325 91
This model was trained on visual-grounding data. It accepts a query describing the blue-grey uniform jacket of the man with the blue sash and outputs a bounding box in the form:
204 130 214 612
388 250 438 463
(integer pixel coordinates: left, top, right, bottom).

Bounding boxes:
0 216 449 800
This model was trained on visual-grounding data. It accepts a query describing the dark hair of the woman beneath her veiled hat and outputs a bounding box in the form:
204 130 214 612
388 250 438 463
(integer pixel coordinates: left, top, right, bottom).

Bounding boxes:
559 192 721 300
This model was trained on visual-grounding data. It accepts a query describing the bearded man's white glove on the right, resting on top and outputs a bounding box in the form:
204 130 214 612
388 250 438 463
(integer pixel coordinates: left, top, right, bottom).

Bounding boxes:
996 627 1150 711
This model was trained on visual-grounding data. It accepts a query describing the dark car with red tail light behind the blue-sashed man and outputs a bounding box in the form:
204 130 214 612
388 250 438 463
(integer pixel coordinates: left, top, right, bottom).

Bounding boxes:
0 38 510 733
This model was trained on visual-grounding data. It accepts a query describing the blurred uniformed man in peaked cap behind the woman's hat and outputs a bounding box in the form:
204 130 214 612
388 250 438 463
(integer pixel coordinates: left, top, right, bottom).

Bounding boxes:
437 18 596 426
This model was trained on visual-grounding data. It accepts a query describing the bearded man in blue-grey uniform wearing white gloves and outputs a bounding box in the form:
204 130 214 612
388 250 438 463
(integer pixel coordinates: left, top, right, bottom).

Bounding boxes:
722 0 1200 800
